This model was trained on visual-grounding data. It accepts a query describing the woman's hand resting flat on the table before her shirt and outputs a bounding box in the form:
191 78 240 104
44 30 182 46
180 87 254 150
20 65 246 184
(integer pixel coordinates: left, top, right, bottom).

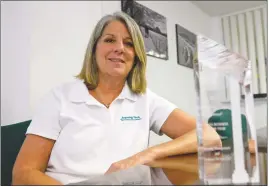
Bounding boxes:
105 149 157 174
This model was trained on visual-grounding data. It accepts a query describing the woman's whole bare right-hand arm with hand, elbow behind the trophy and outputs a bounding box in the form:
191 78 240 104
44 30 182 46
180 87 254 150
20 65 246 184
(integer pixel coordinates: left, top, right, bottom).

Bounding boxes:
104 109 222 173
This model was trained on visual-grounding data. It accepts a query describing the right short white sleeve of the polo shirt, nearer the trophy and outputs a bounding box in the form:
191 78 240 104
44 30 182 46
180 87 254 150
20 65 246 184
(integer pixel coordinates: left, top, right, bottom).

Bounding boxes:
148 90 177 135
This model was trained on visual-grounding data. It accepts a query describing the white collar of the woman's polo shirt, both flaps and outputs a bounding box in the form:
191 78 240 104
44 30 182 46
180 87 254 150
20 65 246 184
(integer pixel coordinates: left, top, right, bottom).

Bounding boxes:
69 80 137 104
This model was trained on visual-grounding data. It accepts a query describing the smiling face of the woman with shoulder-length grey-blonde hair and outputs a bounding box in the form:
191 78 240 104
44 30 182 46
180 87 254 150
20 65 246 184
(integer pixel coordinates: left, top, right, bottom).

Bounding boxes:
96 21 135 78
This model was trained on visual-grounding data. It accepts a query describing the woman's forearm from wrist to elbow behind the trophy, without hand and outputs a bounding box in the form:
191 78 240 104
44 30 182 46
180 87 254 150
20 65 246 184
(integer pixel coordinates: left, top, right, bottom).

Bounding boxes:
149 125 222 159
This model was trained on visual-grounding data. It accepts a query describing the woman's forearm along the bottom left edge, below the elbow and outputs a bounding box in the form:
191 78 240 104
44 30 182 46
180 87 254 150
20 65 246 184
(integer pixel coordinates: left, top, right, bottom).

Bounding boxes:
12 169 63 185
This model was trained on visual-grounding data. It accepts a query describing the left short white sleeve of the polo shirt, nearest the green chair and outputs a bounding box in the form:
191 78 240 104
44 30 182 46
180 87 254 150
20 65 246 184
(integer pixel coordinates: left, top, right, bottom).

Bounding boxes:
26 90 61 140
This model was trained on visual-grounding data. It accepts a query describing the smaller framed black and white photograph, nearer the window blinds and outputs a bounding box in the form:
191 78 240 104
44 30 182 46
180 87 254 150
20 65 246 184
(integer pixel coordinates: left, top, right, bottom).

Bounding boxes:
176 24 196 69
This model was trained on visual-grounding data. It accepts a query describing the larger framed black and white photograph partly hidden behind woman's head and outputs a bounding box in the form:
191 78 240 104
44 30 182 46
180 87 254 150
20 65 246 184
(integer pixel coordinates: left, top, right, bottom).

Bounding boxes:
121 0 168 60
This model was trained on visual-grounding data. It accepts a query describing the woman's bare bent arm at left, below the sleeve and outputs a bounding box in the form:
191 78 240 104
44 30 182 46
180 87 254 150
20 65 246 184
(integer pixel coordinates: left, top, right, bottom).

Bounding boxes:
12 134 62 185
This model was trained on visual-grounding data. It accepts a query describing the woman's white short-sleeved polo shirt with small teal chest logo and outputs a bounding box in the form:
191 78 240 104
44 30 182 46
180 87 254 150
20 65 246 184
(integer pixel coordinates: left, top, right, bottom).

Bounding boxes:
26 80 176 184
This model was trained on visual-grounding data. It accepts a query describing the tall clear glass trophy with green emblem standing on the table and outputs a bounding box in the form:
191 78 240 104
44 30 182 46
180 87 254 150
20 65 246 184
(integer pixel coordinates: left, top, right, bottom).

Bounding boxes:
193 35 260 185
